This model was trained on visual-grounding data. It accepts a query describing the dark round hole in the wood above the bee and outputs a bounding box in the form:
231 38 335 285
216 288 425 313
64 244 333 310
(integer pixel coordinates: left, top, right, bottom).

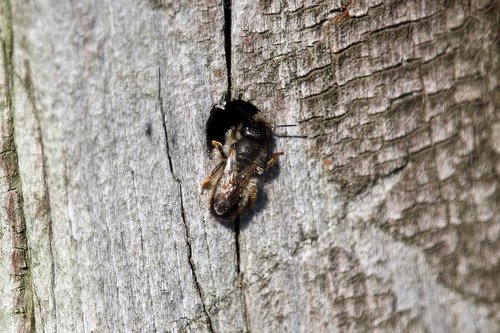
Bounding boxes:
206 99 259 152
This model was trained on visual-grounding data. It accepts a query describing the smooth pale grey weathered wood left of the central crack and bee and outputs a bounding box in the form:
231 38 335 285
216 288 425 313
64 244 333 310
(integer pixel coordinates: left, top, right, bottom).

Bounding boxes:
7 1 243 332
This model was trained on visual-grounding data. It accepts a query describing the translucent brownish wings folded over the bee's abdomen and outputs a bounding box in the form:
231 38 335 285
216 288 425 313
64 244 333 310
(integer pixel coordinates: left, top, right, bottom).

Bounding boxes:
213 150 257 215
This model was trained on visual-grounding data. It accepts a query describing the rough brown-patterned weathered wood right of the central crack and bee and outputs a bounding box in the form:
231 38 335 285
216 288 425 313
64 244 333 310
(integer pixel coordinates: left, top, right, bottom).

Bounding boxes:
231 1 500 332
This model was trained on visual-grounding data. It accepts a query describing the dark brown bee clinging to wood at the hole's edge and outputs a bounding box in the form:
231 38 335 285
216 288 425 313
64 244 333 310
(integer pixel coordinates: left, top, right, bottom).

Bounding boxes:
201 117 283 221
